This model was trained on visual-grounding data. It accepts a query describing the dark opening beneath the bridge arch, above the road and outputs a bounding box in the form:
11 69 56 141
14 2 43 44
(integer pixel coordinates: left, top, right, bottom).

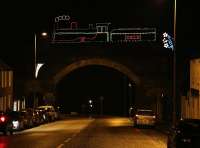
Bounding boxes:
56 65 136 116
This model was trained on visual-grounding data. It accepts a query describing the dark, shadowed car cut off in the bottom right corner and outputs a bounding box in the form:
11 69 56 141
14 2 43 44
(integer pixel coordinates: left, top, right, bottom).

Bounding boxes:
167 119 200 148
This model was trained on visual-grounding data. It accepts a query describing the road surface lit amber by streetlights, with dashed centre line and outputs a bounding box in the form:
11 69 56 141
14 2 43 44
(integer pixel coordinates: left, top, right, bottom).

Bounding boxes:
0 117 166 148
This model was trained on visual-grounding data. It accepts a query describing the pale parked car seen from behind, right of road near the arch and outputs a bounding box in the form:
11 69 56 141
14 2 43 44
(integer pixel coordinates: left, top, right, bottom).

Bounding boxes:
133 109 156 127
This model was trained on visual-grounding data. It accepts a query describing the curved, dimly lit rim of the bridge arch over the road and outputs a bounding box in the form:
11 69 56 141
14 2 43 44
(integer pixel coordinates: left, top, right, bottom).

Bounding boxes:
52 58 141 86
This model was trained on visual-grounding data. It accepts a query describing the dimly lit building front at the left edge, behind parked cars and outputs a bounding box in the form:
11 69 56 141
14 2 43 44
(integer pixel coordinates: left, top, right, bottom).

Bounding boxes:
0 61 13 111
